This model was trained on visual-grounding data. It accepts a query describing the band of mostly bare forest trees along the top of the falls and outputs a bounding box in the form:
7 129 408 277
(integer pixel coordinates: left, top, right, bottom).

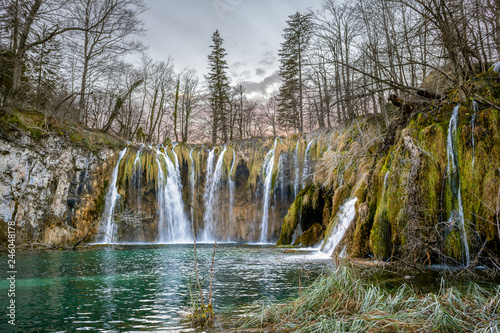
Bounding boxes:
0 0 500 144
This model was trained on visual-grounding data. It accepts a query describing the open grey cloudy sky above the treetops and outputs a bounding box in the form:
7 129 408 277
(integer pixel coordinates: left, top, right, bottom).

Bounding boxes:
142 0 322 97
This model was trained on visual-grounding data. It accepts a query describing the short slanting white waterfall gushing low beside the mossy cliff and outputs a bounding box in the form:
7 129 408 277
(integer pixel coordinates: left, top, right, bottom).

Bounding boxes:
320 198 358 257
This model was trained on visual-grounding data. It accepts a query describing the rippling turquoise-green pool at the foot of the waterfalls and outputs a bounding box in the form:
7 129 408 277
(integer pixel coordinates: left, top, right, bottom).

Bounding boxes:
0 244 329 332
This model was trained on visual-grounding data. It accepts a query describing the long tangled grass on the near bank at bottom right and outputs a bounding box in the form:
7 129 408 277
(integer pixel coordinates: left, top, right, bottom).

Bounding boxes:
237 266 500 332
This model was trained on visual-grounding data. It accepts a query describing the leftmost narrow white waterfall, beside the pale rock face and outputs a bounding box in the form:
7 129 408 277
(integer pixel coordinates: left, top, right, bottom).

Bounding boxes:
101 148 127 244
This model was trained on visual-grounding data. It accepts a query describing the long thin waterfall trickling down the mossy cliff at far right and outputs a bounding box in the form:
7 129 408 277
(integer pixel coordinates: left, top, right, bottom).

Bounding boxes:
446 104 470 266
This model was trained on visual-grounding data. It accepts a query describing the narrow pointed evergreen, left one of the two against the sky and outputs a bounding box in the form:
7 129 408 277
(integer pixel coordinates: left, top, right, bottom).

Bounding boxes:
206 30 230 145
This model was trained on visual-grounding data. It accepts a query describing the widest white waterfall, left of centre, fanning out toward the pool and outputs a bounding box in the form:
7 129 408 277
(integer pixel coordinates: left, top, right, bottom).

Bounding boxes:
156 144 192 243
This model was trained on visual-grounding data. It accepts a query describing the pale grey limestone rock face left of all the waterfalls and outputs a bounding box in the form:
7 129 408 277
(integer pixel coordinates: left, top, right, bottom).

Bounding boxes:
0 133 117 246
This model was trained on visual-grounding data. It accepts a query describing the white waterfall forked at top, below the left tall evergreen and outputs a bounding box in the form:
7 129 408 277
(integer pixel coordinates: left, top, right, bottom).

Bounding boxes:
201 146 226 242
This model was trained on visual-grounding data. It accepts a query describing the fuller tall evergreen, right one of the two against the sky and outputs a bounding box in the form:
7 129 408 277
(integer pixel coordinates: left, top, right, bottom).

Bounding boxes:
278 12 313 132
